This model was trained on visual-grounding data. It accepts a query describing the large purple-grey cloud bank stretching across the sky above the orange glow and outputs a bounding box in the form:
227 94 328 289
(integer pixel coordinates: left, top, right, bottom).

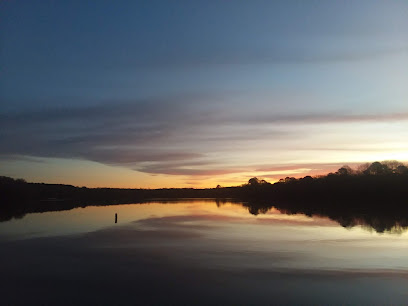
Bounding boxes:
0 95 408 176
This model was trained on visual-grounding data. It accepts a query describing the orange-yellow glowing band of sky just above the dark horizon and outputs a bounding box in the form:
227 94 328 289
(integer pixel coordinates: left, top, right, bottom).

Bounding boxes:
2 158 404 189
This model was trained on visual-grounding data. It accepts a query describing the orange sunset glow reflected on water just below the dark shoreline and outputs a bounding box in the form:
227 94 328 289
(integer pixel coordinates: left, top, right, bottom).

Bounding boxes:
0 200 336 236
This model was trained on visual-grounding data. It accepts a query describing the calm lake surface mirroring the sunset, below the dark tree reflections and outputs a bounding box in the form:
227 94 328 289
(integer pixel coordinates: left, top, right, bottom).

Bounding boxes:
0 200 408 305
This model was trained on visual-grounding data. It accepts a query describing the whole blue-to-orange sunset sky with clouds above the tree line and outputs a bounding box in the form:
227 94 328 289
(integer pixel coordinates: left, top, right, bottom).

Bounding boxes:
0 0 408 188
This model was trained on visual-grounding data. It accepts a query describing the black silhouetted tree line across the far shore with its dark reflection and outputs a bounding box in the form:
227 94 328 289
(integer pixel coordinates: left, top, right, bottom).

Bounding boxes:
0 161 408 225
